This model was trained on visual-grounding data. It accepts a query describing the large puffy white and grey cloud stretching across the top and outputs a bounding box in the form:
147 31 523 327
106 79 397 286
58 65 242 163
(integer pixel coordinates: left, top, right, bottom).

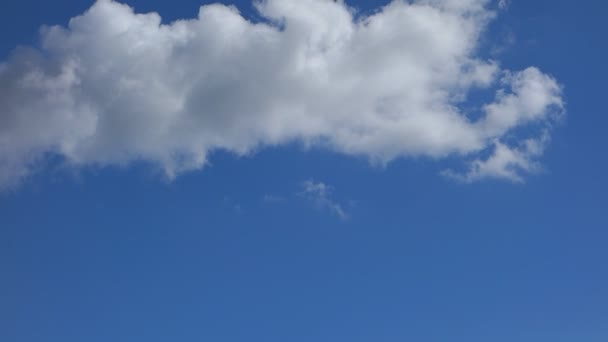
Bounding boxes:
0 0 563 187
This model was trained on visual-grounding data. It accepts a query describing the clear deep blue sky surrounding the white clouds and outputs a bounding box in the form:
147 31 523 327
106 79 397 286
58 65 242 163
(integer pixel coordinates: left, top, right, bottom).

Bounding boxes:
0 0 608 342
